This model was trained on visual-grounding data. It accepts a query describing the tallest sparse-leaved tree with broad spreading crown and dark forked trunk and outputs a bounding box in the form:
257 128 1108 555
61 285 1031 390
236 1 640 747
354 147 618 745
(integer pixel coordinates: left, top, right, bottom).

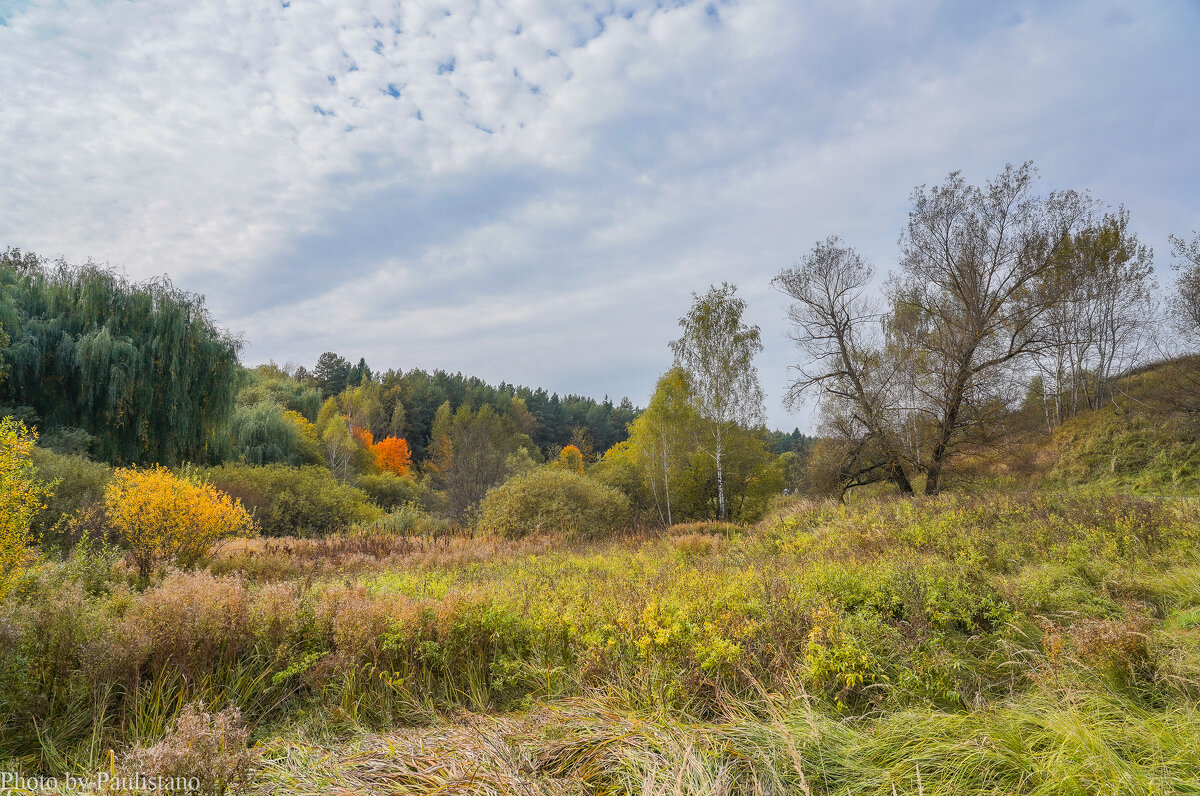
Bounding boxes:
888 163 1090 495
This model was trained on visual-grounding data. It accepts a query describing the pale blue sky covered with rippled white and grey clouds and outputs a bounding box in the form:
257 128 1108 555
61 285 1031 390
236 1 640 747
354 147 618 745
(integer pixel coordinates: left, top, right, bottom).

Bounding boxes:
0 0 1200 430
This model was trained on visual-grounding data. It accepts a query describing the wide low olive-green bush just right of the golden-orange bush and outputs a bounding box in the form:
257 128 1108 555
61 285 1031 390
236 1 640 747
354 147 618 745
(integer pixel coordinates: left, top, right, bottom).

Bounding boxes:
200 465 380 537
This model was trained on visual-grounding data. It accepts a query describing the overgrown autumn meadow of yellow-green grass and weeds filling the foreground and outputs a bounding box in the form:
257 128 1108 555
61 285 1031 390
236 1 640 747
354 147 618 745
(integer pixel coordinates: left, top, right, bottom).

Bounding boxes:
0 491 1200 795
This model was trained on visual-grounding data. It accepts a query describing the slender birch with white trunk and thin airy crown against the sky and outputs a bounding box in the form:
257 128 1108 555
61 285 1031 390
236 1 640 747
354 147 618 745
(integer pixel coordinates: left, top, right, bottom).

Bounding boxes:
671 282 764 520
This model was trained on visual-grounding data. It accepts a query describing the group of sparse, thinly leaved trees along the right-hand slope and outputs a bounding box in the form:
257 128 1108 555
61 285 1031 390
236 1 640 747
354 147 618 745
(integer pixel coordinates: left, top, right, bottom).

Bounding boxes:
774 163 1200 495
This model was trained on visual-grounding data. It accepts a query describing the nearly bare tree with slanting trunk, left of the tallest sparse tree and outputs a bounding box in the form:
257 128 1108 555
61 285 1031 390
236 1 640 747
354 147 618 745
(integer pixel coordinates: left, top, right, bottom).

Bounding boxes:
772 237 913 495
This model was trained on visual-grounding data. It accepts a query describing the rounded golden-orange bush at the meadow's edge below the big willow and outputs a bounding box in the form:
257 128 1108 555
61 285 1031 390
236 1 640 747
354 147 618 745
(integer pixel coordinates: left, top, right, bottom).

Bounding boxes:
104 467 257 577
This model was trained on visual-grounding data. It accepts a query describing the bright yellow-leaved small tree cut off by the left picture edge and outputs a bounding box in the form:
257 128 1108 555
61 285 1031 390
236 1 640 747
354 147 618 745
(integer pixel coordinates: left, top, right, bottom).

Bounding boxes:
0 418 46 593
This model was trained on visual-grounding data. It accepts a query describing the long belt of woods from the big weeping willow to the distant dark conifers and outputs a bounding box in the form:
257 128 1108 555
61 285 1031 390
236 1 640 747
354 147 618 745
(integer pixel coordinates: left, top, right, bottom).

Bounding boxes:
0 250 636 466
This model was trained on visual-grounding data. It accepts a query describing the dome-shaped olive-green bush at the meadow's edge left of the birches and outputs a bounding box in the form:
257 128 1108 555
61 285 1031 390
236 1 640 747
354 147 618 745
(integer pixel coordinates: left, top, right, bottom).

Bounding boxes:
479 467 630 538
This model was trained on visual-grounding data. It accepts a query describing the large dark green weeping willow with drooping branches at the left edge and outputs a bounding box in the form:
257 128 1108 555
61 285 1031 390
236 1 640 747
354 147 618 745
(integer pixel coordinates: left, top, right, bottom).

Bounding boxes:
0 252 241 465
